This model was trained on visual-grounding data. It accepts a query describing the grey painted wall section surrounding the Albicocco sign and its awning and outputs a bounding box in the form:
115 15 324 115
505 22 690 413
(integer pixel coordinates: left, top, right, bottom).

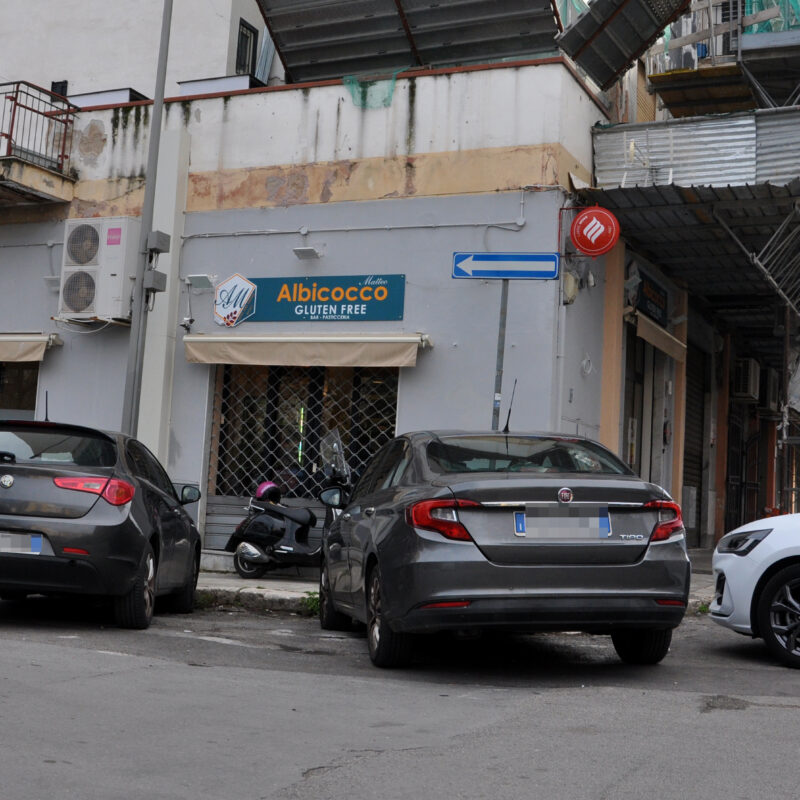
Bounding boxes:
170 191 603 494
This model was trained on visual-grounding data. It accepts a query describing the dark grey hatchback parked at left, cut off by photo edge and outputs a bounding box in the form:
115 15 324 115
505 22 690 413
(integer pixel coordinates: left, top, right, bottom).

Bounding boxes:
0 420 200 628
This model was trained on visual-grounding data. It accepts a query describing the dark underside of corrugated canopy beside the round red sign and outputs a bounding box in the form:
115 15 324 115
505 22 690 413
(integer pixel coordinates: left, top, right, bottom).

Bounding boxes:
579 179 800 368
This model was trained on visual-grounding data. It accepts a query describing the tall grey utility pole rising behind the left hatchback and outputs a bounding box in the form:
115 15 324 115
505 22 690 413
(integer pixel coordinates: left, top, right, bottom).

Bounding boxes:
122 0 172 436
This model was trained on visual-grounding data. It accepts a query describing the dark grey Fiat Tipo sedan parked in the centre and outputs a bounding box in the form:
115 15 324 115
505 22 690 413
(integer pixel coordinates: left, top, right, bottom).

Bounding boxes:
320 431 690 667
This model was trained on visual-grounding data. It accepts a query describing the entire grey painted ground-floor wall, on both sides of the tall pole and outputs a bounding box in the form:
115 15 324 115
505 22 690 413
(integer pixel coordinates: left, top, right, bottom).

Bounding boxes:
0 191 603 524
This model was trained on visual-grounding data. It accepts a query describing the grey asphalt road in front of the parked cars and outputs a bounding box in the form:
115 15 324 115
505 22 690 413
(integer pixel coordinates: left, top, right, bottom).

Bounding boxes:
0 598 800 800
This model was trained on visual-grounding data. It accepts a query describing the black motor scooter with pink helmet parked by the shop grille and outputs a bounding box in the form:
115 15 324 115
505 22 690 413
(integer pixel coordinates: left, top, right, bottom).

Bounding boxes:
225 481 322 578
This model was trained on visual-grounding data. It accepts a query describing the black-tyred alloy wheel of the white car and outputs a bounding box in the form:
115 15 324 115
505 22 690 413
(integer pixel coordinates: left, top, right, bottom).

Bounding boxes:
756 564 800 668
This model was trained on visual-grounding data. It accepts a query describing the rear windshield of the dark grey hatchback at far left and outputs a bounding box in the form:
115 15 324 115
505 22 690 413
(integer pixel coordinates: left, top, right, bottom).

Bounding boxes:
0 423 117 467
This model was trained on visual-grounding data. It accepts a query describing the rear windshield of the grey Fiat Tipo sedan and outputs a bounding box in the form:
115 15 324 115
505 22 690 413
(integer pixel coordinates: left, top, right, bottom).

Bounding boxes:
427 434 631 475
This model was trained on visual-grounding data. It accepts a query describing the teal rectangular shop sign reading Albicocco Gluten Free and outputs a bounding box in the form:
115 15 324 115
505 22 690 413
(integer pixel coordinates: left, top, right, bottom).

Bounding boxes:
234 275 406 322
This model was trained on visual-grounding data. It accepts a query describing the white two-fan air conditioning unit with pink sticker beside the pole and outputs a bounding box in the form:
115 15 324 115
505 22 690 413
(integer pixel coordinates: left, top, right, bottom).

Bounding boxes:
58 217 141 320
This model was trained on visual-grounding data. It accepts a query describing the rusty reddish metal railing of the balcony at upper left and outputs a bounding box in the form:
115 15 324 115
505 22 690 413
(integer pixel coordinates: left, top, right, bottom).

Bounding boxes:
0 81 80 173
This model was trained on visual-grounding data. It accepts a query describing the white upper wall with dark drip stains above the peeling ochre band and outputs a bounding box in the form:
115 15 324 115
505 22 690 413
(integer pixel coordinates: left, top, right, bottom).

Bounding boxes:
73 64 601 180
